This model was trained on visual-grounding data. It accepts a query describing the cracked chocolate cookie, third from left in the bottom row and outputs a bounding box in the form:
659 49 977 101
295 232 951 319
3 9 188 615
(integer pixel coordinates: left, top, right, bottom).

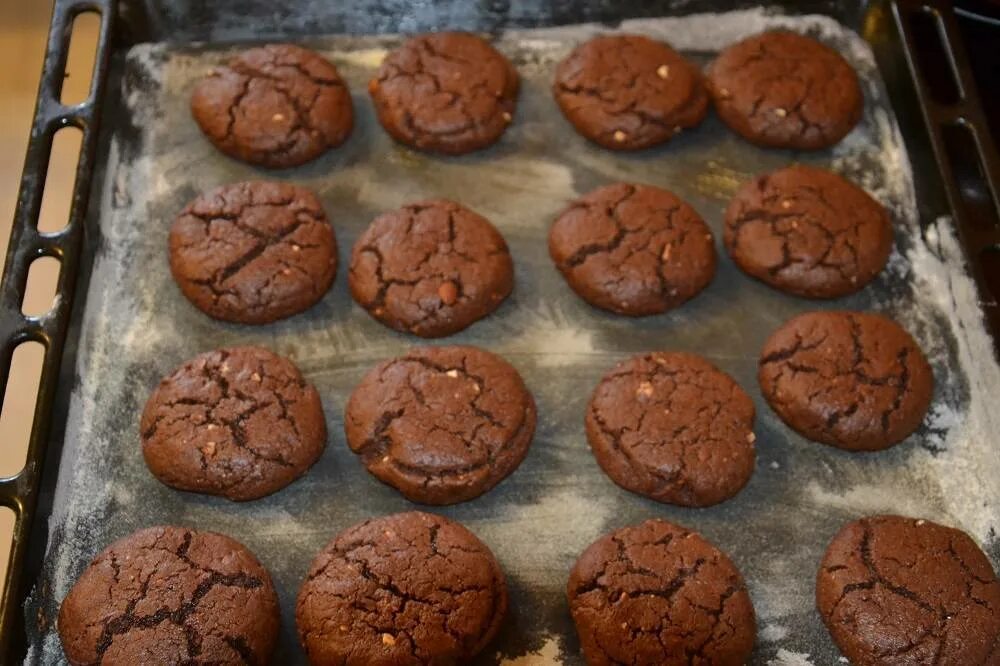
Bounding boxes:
566 520 757 666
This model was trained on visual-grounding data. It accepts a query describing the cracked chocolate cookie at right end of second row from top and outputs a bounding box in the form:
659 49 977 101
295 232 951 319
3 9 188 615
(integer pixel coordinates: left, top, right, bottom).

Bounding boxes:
723 165 892 298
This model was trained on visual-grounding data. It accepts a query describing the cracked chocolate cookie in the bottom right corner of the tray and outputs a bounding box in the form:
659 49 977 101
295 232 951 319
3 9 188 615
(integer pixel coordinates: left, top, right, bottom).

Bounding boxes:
816 516 1000 666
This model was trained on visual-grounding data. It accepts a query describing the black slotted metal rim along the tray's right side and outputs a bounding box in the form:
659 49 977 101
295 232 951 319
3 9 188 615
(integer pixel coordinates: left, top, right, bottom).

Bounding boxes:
893 0 1000 358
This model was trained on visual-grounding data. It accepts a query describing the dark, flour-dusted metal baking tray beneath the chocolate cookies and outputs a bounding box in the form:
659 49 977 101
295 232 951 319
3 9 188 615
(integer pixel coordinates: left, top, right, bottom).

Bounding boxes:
4 3 1000 664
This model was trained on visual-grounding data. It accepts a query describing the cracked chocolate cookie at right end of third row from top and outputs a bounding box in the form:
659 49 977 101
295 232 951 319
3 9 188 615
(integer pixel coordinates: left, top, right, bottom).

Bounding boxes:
757 311 934 451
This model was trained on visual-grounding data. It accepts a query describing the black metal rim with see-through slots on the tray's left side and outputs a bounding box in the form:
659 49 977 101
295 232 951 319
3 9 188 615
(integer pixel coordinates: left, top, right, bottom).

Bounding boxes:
0 0 115 663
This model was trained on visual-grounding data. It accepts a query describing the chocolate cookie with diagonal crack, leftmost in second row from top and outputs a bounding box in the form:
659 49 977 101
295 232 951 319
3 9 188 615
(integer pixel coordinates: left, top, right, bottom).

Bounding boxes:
170 181 337 324
